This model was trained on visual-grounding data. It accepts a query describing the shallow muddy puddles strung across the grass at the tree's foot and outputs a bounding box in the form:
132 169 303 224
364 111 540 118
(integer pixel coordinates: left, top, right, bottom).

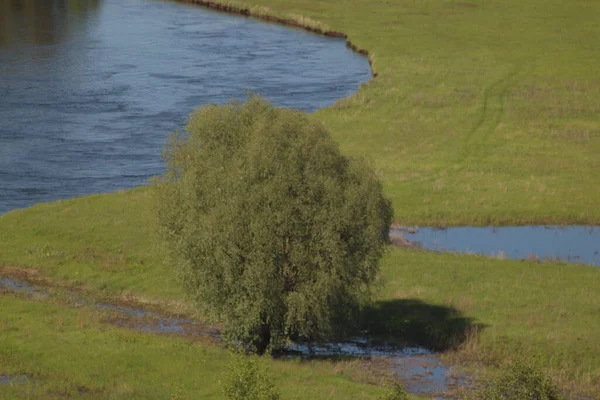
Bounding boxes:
0 277 467 400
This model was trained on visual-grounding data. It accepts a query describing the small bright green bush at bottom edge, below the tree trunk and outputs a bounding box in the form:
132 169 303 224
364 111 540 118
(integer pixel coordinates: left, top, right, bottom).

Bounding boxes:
223 353 279 400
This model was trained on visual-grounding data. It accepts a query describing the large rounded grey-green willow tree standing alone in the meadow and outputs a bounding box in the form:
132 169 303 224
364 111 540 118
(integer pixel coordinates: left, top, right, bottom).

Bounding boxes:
153 96 392 353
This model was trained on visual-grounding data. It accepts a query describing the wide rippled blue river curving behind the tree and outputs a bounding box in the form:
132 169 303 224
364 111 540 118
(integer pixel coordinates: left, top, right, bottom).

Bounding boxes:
0 0 370 214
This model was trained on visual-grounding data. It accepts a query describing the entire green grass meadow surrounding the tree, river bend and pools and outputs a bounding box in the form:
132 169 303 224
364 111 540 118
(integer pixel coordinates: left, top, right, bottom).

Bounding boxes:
0 0 600 400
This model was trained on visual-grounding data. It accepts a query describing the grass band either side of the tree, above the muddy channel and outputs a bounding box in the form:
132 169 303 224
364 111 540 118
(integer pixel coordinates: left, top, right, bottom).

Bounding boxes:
0 189 600 398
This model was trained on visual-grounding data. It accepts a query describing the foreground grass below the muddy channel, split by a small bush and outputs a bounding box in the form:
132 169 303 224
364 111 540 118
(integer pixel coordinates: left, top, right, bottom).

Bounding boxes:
0 295 414 400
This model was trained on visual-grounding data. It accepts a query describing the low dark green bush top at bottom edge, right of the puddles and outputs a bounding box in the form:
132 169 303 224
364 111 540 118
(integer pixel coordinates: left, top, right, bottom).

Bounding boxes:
475 362 563 400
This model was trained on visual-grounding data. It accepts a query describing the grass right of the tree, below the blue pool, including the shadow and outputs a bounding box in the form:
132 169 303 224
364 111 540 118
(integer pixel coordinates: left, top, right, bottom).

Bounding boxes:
375 249 600 398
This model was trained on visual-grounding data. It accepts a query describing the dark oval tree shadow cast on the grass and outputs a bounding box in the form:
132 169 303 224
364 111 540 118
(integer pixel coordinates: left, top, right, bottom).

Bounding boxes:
362 299 485 351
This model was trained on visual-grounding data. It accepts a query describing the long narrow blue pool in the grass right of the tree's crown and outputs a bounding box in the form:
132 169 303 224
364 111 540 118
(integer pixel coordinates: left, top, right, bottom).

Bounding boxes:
390 226 600 266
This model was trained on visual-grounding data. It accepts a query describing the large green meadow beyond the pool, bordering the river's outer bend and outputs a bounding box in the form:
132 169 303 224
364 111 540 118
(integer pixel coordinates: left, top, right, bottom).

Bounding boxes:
176 0 600 225
